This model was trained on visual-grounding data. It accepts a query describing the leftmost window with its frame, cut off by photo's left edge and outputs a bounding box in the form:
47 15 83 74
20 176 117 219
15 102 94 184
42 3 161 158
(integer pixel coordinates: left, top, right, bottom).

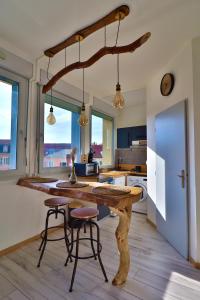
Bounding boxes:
0 68 28 178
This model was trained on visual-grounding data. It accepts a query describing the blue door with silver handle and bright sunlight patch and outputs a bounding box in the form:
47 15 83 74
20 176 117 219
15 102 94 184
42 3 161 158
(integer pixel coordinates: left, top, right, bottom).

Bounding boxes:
156 101 188 258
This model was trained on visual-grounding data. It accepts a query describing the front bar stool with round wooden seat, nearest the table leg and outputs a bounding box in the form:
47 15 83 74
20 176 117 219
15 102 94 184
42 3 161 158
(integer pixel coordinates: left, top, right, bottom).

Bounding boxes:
65 207 108 292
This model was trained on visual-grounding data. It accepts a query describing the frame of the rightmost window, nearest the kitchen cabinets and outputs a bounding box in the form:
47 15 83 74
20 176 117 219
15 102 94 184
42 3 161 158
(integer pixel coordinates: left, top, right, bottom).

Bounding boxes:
89 108 115 169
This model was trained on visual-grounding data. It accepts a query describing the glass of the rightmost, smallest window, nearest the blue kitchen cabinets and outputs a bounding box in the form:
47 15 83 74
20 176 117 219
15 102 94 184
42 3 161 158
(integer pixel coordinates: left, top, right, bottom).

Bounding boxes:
91 111 113 166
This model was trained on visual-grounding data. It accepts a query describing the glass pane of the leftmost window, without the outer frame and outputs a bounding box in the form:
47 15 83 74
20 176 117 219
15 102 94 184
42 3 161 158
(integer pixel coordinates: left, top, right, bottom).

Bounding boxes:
0 79 19 171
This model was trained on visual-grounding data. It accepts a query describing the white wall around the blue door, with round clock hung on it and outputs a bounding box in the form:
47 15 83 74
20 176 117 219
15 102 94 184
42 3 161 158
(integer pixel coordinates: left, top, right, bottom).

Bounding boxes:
147 43 198 260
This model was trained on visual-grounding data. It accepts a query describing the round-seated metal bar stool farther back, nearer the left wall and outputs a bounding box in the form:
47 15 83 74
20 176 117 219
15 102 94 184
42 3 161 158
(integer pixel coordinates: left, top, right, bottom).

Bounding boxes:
37 197 72 268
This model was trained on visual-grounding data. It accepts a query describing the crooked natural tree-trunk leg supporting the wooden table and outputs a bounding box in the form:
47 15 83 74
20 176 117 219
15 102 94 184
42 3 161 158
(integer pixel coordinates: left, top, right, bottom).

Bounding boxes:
111 201 132 285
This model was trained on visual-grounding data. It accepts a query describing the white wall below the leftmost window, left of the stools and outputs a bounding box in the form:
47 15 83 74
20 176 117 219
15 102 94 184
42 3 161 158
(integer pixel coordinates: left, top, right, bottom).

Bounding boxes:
0 180 63 250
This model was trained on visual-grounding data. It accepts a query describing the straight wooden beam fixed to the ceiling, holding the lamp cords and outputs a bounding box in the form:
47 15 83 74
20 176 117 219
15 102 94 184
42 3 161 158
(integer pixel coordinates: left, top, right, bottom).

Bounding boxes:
44 5 129 57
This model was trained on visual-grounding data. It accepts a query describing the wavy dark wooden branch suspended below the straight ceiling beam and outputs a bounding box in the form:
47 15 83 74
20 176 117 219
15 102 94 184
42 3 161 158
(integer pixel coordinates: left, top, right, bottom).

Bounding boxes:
42 32 151 93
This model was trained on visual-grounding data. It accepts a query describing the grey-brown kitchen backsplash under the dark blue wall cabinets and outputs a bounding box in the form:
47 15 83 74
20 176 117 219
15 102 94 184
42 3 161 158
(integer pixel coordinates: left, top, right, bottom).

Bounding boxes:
115 147 147 167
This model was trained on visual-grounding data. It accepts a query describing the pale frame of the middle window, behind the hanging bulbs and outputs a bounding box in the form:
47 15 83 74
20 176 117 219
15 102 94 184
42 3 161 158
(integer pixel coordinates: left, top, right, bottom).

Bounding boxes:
37 86 83 175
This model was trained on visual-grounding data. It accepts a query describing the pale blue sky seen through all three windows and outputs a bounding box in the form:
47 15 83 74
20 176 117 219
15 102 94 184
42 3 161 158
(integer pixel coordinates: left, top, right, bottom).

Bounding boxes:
0 81 103 144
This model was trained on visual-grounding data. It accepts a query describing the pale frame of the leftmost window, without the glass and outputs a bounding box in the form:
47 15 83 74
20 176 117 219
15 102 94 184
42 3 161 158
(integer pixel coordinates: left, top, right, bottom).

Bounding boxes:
0 67 29 180
